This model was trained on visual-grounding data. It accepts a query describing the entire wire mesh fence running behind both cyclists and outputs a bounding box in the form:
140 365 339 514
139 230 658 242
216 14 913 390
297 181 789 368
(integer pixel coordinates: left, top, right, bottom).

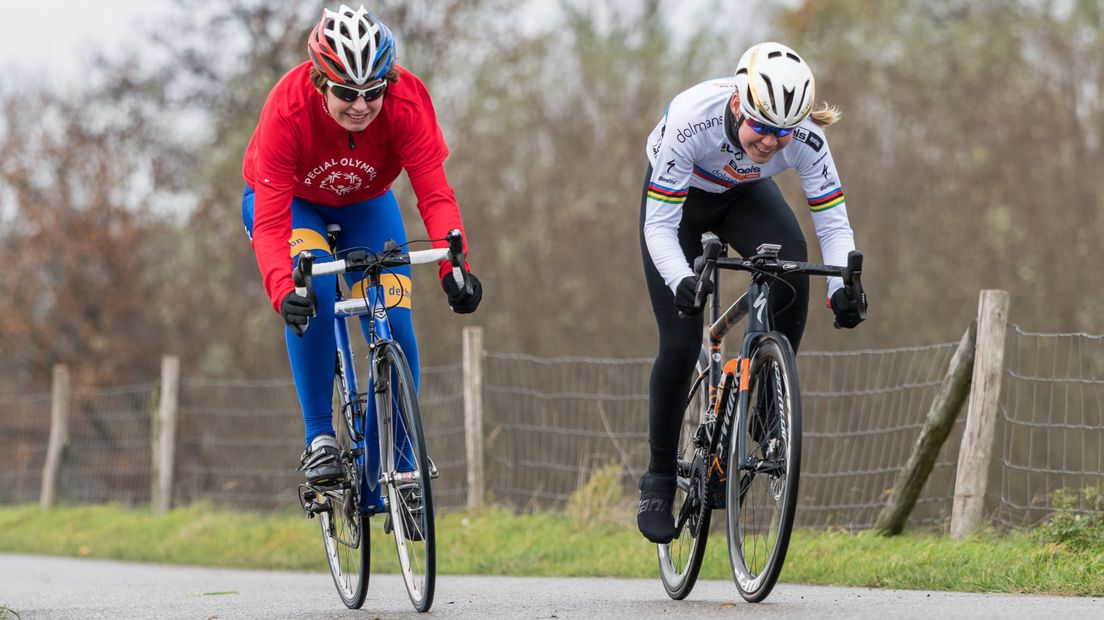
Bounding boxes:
0 327 1104 530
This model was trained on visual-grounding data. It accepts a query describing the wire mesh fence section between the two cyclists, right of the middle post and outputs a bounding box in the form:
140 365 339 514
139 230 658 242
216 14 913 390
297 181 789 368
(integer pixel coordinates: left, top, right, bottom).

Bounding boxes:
484 353 652 510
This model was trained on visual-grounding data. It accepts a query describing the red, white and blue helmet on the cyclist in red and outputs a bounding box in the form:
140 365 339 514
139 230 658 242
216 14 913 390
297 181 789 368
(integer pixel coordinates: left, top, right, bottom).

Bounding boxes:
307 4 395 86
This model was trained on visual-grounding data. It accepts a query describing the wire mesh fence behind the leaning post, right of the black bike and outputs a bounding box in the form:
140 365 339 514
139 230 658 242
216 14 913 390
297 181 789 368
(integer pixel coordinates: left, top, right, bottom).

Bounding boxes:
797 342 963 530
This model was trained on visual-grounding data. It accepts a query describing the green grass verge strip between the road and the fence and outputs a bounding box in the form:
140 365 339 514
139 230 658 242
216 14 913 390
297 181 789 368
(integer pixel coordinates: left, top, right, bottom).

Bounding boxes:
0 505 1104 595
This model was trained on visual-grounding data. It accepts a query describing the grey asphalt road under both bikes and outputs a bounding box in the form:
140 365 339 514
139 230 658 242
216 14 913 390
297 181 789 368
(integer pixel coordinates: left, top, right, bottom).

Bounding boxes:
0 554 1104 620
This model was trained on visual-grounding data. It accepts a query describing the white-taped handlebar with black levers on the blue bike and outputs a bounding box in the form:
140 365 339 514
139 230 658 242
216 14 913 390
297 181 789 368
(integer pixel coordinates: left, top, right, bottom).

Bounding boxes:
291 228 471 335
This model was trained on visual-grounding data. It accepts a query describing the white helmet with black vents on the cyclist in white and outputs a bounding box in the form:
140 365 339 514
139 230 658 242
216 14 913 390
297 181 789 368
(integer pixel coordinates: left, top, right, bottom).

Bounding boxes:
736 42 816 128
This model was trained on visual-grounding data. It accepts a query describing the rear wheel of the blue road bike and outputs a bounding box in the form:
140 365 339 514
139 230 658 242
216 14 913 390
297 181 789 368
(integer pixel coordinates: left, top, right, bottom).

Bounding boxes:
318 353 371 609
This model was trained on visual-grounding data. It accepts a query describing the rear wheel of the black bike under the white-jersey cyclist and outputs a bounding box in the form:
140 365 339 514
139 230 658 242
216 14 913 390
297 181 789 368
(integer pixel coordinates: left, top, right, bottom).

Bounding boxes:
657 348 712 600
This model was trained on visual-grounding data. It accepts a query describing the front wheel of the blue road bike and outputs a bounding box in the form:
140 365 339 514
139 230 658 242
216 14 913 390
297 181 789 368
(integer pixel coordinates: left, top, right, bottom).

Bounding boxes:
376 343 437 611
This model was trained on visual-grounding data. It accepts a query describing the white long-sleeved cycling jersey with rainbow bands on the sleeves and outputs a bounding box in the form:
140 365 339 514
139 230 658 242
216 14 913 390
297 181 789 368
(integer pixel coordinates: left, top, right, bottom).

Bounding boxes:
644 78 854 297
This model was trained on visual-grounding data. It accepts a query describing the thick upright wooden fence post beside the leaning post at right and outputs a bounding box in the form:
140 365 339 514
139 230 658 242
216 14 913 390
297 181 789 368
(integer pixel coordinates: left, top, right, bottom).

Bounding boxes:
951 290 1008 538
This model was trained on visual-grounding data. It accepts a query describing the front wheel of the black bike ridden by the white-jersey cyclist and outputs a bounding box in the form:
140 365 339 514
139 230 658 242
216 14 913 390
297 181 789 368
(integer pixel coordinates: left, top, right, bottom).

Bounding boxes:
728 332 802 602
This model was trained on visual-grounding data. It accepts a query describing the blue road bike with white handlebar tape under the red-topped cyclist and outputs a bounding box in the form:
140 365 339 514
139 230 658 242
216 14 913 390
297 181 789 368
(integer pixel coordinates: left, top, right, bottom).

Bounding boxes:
293 225 470 611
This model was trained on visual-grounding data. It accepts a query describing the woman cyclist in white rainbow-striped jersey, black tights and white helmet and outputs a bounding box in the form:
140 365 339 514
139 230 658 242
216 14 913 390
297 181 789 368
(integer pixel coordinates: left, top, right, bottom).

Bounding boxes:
637 42 862 543
